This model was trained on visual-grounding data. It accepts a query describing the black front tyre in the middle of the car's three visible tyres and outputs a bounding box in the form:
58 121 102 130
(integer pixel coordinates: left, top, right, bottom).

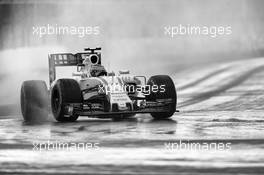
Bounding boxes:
51 79 83 122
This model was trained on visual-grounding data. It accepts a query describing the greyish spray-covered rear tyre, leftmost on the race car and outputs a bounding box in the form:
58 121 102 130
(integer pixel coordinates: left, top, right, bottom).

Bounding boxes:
20 80 49 122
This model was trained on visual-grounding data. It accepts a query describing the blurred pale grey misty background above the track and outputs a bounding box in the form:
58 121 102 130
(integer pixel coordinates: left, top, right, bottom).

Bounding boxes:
0 0 264 115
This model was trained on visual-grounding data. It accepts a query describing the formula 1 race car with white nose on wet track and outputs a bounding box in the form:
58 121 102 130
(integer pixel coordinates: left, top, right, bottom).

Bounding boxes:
21 48 177 122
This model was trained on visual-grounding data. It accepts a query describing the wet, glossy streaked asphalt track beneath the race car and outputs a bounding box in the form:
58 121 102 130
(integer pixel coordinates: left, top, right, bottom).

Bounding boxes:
0 58 264 174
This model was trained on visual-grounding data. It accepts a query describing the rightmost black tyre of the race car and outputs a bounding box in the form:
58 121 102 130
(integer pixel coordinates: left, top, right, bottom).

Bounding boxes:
146 75 177 119
